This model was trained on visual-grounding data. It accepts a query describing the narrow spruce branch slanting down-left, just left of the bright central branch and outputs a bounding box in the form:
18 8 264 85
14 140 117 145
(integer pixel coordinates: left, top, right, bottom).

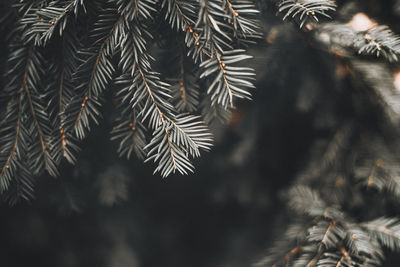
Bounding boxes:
66 6 121 139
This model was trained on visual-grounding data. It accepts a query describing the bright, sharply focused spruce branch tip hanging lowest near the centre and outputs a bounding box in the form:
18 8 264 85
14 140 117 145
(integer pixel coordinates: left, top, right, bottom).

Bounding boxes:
133 68 212 177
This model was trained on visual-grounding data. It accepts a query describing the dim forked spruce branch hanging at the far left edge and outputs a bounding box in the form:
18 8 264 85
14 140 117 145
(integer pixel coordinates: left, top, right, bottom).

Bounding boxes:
0 40 58 197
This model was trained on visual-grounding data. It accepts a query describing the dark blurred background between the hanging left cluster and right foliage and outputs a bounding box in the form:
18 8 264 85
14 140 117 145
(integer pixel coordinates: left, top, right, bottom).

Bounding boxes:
0 0 400 267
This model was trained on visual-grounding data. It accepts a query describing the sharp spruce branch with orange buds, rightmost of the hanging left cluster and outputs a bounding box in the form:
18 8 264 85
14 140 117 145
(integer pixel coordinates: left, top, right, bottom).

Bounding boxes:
164 0 257 109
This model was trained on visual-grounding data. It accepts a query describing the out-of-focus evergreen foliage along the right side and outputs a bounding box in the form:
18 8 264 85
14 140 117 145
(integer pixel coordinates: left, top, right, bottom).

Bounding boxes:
256 0 400 267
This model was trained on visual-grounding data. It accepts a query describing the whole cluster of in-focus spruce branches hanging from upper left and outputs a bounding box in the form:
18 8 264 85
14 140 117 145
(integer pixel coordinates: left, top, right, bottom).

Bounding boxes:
0 0 260 202
